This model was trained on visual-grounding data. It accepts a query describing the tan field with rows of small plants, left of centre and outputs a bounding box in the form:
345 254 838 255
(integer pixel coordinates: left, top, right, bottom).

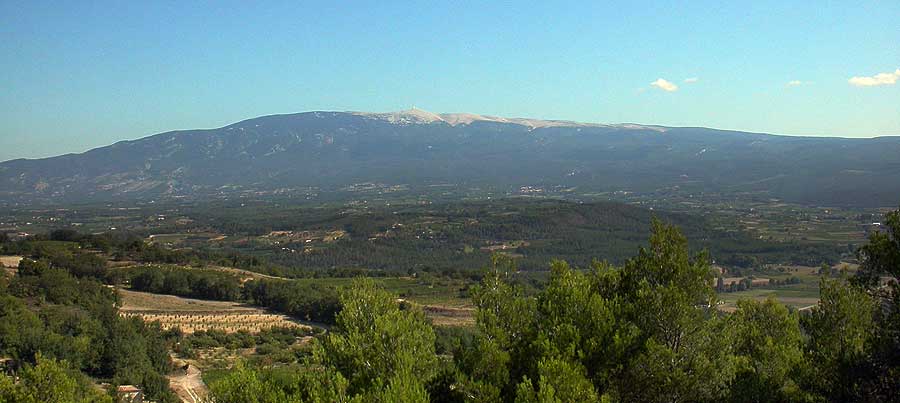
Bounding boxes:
119 290 306 334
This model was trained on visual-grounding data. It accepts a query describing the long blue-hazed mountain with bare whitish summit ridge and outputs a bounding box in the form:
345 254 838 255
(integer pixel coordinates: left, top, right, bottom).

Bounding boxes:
0 109 900 206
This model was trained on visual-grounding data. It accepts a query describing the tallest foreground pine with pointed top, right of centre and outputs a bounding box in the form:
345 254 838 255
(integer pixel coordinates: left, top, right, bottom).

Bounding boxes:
617 220 734 402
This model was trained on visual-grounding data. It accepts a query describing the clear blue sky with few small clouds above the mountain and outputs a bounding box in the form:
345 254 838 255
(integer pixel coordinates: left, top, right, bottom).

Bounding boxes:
0 0 900 160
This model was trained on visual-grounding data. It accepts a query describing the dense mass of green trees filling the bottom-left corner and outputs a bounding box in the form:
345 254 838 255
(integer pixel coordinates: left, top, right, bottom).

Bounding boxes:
0 260 176 402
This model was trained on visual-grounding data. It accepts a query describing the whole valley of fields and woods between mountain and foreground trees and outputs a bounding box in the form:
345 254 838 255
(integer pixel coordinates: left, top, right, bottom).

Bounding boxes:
0 166 890 403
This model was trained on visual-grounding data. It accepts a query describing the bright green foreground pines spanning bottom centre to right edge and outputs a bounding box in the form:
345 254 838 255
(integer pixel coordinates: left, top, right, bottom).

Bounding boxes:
213 213 900 403
